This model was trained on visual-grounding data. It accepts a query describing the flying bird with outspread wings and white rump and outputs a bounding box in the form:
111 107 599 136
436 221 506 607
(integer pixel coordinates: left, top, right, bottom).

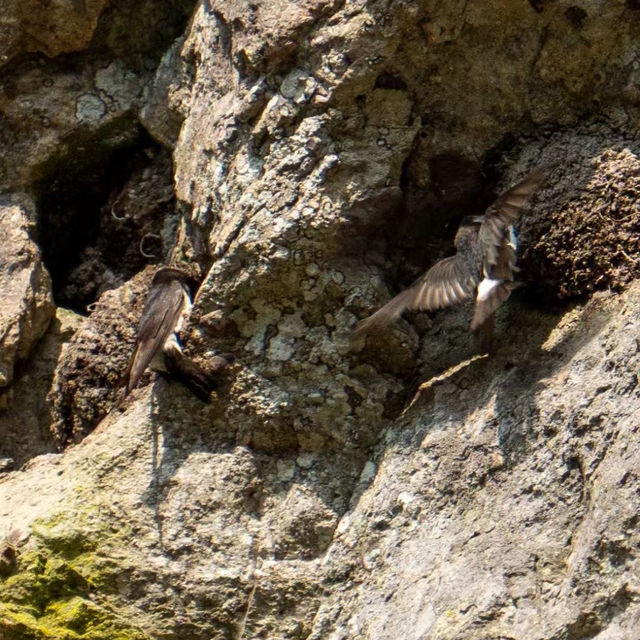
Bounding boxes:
354 169 545 336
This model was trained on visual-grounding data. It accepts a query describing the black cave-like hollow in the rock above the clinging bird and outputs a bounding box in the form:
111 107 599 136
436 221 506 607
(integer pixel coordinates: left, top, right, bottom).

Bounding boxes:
36 130 170 313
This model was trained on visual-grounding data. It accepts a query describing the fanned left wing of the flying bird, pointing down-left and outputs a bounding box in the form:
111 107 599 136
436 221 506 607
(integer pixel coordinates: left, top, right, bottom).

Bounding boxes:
355 255 478 335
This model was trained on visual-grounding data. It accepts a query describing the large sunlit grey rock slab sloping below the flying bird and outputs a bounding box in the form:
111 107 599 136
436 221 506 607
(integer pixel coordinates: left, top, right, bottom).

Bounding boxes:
310 284 640 640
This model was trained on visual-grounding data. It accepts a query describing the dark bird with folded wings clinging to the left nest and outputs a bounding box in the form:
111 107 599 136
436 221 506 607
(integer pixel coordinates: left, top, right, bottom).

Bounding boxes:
118 267 229 404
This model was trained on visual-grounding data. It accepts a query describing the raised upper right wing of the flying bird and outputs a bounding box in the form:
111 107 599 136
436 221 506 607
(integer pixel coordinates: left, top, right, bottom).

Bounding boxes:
478 169 546 265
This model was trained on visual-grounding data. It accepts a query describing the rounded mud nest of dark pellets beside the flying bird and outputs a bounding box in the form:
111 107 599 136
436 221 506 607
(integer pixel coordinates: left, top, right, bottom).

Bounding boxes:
519 141 640 299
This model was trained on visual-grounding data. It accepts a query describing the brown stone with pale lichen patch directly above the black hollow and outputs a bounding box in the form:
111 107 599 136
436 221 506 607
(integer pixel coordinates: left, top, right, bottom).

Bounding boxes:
0 53 145 190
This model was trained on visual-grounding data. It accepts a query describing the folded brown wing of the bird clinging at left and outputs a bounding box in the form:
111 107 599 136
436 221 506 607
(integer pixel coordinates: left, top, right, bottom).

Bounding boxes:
125 280 185 393
